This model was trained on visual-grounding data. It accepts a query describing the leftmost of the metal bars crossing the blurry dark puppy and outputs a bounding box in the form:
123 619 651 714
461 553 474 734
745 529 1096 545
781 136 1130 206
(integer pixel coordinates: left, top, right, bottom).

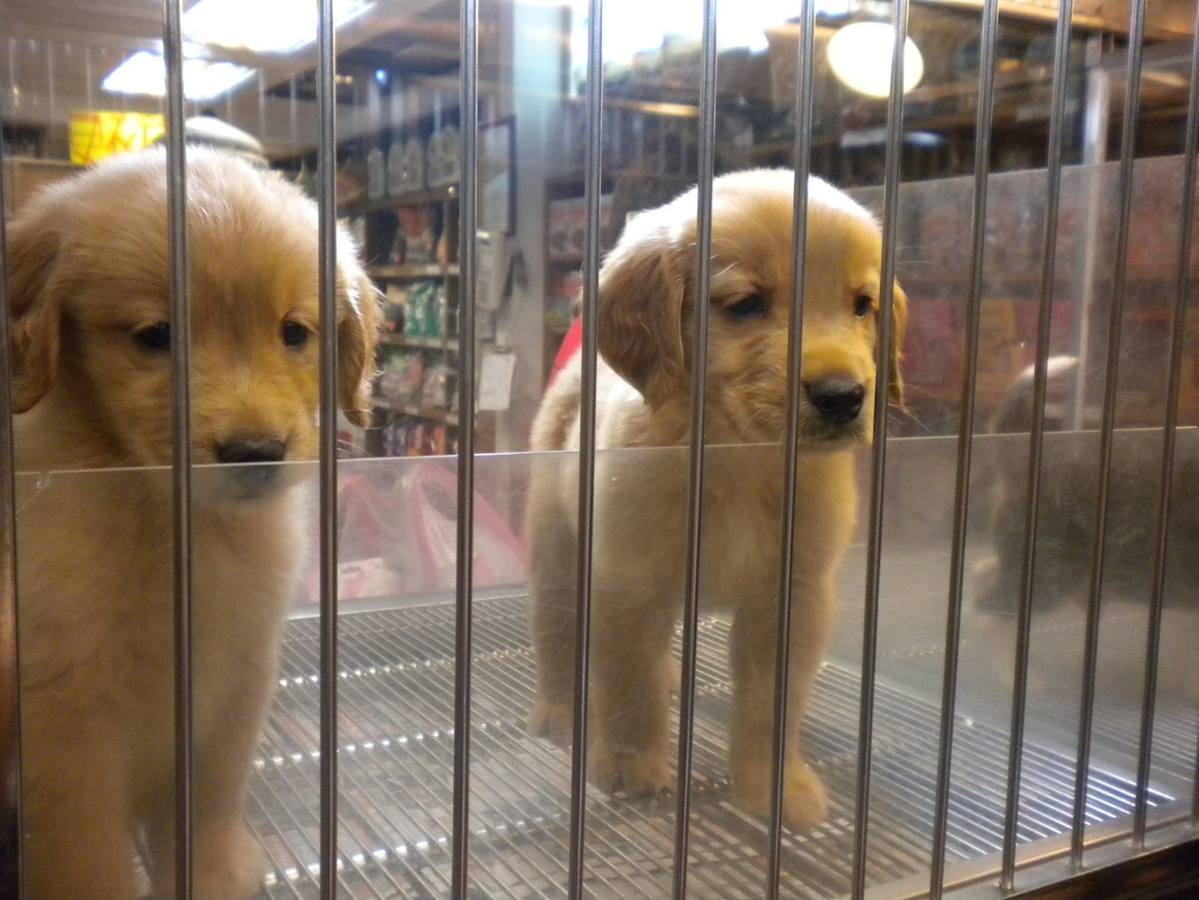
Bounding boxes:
1000 0 1074 890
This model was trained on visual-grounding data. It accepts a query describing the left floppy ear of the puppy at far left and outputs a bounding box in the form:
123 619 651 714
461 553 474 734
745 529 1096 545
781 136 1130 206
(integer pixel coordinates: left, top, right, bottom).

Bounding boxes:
6 198 62 412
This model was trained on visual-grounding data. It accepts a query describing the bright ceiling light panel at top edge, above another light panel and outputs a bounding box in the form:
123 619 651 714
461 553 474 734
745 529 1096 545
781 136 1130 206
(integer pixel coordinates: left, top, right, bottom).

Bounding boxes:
183 0 374 53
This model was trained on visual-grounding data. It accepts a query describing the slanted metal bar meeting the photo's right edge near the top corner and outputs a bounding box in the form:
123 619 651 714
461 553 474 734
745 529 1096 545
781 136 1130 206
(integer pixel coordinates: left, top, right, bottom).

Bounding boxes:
1121 0 1184 847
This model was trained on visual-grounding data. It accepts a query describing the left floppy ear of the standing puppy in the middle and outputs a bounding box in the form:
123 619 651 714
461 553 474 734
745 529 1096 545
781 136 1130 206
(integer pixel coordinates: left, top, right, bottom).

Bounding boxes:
597 219 686 406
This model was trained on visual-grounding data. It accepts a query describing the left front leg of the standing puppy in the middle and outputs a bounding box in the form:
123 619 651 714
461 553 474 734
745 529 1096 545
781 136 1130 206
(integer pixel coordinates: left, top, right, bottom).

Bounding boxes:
590 594 677 796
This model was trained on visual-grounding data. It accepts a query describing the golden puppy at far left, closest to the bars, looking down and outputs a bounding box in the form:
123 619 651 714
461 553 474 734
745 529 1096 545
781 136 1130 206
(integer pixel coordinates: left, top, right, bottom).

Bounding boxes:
8 150 380 900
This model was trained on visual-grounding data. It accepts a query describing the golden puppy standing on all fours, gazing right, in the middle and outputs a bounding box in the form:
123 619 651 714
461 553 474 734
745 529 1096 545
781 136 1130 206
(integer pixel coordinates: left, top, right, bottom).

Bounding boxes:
529 170 906 827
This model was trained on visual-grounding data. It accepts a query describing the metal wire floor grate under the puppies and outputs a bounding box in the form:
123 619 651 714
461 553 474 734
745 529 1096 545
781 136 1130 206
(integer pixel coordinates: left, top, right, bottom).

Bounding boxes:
251 597 1189 899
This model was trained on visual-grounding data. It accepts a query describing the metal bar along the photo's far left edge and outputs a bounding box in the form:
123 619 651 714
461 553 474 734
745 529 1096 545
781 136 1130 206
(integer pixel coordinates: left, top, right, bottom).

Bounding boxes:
0 98 20 898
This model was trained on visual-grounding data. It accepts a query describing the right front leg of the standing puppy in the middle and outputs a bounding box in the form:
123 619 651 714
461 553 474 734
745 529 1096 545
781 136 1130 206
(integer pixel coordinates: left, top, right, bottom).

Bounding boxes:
729 590 836 828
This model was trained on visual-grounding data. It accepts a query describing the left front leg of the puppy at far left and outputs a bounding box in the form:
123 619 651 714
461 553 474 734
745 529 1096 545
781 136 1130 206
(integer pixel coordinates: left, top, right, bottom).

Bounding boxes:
22 709 135 900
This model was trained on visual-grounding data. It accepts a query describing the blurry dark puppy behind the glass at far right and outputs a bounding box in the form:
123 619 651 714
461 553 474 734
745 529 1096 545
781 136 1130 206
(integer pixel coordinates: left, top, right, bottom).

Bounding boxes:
975 356 1199 696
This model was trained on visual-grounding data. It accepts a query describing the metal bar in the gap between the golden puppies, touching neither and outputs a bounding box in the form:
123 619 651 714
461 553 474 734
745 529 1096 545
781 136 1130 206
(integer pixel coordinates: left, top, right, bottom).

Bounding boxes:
450 0 478 900
